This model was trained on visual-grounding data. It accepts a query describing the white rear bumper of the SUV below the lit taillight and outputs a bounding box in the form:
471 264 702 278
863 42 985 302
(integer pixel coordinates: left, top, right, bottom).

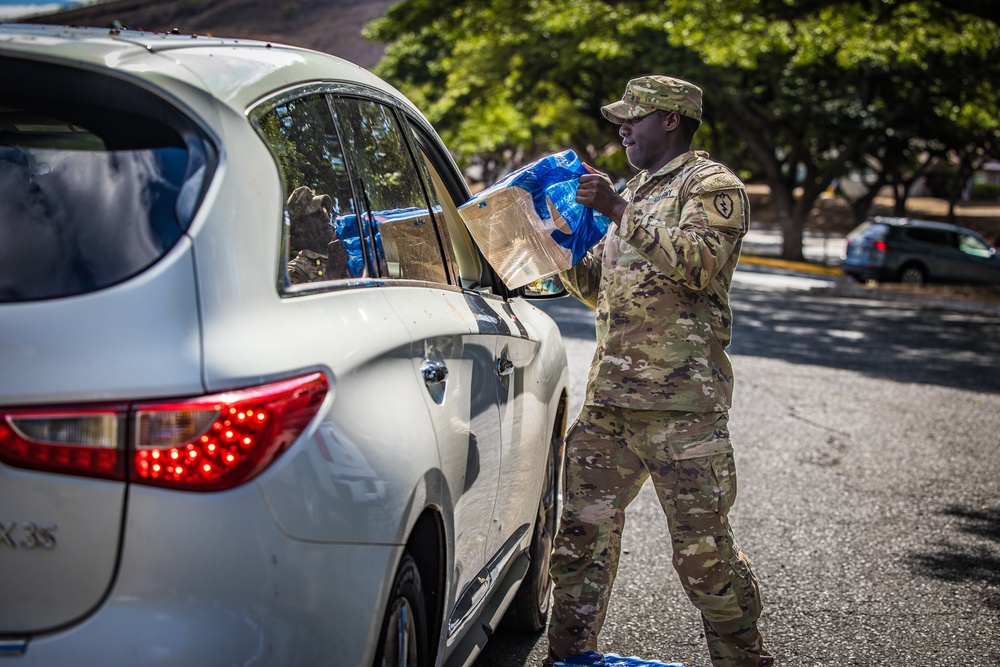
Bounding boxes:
11 484 398 667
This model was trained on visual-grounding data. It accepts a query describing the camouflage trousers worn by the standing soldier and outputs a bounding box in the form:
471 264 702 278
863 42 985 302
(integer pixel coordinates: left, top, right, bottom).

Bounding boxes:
548 406 773 667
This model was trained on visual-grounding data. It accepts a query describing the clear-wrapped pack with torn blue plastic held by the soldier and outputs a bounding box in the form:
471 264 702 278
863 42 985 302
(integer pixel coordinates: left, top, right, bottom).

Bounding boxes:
458 150 610 289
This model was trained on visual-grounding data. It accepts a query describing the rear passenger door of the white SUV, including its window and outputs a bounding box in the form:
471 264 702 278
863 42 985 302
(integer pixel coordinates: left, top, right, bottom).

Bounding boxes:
333 96 502 639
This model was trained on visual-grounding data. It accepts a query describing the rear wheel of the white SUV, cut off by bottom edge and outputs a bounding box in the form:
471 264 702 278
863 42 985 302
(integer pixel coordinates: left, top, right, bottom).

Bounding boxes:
374 553 428 667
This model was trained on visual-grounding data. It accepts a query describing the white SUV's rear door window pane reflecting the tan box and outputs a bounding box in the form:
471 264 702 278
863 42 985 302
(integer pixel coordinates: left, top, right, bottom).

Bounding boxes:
334 98 448 283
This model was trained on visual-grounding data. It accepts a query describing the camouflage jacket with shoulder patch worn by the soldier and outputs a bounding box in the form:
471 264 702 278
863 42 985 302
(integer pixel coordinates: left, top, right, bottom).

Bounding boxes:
560 151 750 412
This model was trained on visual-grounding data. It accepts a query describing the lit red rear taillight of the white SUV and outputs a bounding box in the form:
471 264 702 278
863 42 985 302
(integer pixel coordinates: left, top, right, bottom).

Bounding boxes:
0 373 328 491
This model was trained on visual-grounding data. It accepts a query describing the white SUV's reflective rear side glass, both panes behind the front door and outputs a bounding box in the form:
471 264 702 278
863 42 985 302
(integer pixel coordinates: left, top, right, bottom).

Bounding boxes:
252 89 452 293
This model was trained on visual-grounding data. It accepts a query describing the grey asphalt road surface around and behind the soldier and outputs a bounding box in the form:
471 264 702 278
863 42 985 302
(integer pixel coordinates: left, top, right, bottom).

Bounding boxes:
476 270 1000 667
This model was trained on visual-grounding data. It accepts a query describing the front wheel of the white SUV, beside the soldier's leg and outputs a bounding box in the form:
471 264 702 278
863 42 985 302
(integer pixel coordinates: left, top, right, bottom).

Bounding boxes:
504 434 562 633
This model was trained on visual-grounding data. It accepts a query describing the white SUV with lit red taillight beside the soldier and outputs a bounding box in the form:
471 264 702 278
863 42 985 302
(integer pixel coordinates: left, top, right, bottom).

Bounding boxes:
0 25 567 667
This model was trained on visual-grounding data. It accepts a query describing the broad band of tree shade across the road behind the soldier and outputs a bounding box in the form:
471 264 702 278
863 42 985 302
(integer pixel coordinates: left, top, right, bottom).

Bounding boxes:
535 288 1000 393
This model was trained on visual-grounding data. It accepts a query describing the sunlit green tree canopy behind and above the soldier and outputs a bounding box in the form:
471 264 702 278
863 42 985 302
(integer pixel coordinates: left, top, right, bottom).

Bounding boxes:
366 0 1000 259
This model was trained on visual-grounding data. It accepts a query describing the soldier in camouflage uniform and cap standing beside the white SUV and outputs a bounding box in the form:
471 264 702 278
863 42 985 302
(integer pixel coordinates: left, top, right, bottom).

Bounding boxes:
546 76 773 667
